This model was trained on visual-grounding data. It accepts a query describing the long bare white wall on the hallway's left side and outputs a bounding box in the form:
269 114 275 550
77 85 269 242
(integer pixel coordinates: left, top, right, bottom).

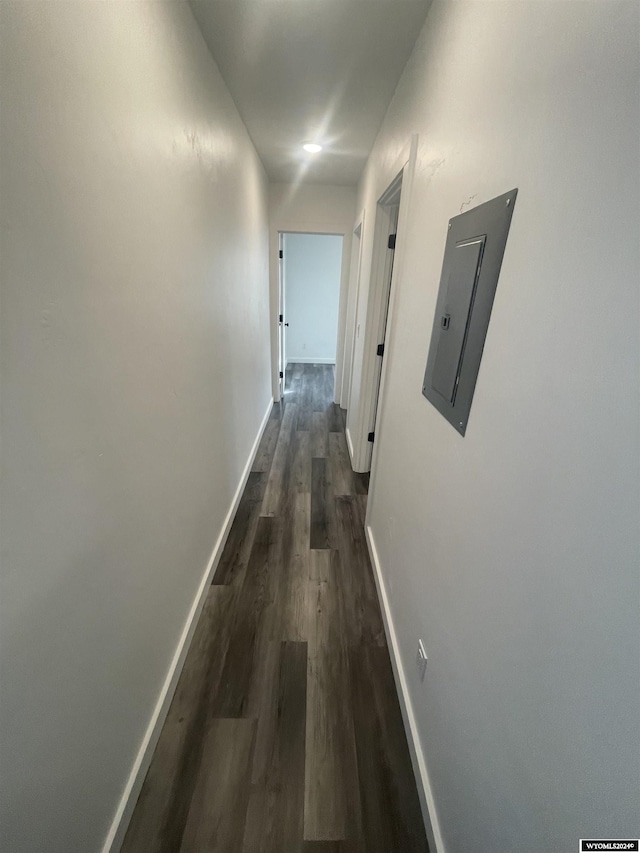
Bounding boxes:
0 2 271 853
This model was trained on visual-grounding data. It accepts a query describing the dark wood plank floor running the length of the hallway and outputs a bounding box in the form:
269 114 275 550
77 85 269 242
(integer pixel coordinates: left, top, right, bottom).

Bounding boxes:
122 364 427 853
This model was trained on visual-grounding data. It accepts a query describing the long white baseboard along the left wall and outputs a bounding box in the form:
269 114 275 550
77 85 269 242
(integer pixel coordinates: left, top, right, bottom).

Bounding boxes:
102 398 273 853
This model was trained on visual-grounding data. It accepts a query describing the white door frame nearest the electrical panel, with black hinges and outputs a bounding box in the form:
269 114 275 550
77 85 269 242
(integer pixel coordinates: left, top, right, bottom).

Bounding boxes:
348 134 418 476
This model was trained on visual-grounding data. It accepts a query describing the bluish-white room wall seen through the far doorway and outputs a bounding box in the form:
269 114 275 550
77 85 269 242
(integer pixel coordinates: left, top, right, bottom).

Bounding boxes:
284 234 343 364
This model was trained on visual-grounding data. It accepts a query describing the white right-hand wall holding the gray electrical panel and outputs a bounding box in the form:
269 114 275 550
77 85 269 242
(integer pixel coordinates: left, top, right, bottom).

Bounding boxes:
358 0 640 853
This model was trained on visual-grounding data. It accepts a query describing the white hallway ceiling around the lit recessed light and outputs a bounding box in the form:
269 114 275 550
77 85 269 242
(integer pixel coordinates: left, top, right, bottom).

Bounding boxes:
190 0 430 184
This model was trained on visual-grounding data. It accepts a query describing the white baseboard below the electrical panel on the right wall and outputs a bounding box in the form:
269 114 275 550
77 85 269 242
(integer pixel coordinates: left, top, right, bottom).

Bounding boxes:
365 525 445 853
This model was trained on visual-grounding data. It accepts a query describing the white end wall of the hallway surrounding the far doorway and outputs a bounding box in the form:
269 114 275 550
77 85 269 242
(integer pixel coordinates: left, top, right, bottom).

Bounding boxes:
269 184 356 401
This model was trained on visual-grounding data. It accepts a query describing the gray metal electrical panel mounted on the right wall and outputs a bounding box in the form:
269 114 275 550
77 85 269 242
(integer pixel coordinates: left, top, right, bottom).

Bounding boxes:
422 189 518 435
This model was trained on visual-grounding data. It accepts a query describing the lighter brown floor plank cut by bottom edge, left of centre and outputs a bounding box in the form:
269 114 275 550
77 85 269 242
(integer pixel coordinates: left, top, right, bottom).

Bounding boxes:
180 719 256 853
